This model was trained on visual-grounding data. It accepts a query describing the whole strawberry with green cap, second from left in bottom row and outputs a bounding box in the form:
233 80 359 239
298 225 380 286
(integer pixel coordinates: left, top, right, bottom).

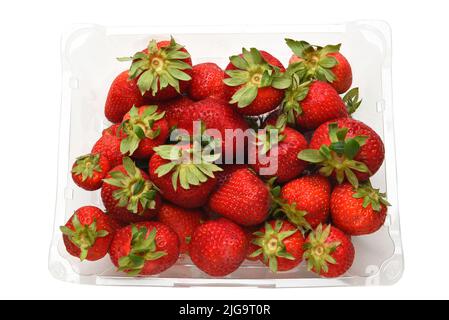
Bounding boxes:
109 222 179 276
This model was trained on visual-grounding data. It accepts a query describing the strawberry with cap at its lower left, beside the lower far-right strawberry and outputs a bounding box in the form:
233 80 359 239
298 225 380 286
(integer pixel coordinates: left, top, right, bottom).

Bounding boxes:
280 175 331 229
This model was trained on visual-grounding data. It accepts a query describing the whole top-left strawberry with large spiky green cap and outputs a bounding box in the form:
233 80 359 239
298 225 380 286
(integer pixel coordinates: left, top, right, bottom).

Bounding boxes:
119 38 192 102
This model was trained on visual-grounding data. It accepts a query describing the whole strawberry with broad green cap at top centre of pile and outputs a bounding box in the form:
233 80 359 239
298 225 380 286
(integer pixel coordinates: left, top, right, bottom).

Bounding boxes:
224 48 291 116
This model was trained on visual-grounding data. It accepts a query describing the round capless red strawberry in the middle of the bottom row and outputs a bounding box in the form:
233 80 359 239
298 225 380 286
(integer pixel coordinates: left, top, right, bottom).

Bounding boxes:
190 218 248 277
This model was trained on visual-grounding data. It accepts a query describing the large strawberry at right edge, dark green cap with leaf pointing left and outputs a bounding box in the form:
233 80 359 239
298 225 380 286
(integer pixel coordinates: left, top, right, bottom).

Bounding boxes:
298 118 385 187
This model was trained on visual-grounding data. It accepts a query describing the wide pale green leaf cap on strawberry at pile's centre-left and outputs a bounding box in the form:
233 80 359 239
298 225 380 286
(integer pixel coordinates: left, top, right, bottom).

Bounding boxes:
154 141 223 191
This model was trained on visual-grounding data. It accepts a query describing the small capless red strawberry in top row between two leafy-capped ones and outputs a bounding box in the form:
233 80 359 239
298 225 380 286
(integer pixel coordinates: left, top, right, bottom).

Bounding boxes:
189 63 224 101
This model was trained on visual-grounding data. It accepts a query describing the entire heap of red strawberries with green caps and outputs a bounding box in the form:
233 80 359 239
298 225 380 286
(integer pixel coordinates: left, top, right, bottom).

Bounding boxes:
60 38 389 277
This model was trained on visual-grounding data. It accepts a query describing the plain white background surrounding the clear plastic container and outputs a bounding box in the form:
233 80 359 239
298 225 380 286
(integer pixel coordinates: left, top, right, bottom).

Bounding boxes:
0 0 449 299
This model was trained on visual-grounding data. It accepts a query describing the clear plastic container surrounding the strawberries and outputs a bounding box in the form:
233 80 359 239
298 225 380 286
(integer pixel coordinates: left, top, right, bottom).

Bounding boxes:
49 21 403 287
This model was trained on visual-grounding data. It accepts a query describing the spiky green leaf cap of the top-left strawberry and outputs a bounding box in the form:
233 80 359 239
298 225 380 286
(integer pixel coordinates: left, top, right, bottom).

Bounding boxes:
118 37 192 96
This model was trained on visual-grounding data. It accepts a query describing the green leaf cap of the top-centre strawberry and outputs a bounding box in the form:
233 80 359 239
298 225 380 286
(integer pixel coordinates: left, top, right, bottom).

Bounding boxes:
223 48 291 108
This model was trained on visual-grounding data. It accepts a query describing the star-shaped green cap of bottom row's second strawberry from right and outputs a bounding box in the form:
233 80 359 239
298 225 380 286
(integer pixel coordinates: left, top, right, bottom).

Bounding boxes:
250 220 299 273
